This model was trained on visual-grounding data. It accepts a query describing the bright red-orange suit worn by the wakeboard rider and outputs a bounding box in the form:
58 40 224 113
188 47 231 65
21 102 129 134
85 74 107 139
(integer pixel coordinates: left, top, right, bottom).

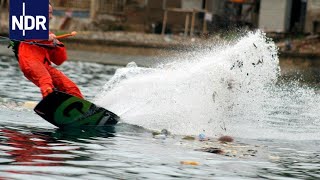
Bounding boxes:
18 36 83 98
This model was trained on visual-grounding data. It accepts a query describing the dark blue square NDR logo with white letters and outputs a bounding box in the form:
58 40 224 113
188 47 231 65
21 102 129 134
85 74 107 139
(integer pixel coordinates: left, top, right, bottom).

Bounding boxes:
9 0 49 40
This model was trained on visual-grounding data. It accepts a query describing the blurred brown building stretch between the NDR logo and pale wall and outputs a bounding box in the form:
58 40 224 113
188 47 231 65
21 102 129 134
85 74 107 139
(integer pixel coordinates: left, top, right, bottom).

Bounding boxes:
51 0 260 33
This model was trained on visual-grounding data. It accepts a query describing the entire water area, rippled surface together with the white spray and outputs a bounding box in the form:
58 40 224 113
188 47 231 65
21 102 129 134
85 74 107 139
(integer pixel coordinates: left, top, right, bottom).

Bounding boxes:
0 31 320 179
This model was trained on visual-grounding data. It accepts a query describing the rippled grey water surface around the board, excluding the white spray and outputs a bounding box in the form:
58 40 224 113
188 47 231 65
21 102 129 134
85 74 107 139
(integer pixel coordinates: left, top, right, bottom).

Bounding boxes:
0 52 320 179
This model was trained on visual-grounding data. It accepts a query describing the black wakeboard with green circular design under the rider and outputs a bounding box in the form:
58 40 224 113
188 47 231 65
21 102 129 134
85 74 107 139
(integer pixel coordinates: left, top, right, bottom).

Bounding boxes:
34 91 119 128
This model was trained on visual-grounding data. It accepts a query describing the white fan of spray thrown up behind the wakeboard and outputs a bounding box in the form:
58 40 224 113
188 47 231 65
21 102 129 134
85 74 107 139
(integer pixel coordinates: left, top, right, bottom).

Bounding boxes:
94 31 318 138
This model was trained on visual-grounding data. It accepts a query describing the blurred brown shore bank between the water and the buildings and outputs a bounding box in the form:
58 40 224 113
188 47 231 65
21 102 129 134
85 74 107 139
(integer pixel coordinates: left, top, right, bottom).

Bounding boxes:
0 32 320 66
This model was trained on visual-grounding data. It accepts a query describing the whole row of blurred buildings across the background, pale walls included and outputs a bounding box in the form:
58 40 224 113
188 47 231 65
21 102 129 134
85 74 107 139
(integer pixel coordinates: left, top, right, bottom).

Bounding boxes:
0 0 320 34
